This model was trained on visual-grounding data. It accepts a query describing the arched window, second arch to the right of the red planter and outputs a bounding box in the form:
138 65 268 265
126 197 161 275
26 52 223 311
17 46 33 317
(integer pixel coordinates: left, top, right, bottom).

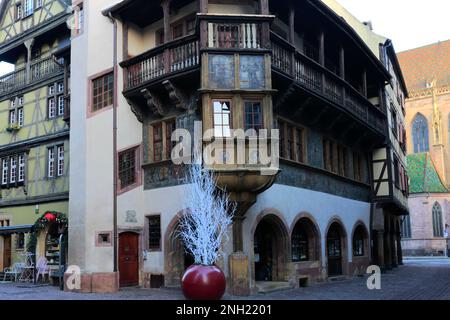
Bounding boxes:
291 218 320 262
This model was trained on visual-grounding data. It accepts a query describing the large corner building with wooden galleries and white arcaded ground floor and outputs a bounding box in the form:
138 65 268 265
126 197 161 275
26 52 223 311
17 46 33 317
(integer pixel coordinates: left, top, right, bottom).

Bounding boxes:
64 0 404 295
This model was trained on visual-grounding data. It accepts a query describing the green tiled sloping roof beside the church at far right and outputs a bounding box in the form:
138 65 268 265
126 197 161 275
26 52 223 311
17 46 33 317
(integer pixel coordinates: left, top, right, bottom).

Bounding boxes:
407 153 450 193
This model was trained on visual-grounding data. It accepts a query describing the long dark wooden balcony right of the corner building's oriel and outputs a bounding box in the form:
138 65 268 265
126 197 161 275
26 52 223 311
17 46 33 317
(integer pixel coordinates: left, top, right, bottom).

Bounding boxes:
271 34 385 135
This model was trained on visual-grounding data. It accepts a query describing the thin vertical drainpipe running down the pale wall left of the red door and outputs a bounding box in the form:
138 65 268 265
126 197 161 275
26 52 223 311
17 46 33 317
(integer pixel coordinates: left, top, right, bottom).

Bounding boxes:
108 12 119 272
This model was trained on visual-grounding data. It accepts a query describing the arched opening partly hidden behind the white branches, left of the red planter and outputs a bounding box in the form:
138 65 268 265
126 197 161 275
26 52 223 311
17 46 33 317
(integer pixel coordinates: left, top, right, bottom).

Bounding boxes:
165 219 195 287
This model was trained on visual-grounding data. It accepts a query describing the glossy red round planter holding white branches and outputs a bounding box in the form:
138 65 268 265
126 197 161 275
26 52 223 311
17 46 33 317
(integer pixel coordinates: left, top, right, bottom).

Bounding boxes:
182 265 226 300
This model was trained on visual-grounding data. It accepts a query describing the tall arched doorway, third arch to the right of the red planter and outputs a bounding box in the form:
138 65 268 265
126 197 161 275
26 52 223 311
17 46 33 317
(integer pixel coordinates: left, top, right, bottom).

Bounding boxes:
327 222 345 277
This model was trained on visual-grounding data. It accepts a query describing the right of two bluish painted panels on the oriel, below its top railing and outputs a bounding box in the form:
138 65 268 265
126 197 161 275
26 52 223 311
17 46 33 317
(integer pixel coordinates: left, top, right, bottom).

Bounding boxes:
239 56 265 89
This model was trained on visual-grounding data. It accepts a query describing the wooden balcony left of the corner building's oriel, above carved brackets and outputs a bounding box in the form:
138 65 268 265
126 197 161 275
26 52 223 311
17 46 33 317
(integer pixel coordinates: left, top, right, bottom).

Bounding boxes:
121 35 200 91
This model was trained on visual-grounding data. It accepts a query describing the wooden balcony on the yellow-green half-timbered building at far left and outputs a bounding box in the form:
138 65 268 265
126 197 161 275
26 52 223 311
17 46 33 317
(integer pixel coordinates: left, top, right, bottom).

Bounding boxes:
0 57 63 96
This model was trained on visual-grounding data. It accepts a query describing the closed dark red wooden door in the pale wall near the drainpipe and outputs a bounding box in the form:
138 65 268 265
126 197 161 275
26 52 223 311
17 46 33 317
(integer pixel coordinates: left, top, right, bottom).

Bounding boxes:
119 232 139 287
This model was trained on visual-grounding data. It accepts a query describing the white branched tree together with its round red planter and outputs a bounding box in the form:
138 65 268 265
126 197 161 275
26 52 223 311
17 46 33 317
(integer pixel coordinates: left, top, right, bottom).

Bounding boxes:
179 165 236 300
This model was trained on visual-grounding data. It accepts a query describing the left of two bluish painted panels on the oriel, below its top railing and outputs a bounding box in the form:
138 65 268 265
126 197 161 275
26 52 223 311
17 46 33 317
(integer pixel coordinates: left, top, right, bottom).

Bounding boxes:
209 54 235 89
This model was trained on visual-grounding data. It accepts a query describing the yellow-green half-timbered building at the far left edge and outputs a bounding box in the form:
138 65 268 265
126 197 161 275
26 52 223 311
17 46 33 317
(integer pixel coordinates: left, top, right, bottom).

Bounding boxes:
0 0 70 271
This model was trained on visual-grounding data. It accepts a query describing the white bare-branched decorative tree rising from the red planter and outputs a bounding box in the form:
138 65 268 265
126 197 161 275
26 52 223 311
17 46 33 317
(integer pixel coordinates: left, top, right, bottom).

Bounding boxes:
178 164 236 266
